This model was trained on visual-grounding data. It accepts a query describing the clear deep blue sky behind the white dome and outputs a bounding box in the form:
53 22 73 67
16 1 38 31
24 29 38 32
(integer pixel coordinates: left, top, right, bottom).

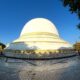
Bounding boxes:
0 0 80 44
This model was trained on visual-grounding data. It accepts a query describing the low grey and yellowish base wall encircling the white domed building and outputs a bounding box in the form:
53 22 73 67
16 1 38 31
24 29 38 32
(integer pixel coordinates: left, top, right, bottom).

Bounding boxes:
4 50 76 60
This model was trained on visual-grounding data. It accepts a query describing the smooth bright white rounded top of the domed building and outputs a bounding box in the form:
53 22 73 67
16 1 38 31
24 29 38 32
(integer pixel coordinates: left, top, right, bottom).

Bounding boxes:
20 18 59 36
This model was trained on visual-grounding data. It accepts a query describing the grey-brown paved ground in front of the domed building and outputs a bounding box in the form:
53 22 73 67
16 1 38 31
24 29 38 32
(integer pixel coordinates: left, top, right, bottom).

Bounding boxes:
0 56 80 80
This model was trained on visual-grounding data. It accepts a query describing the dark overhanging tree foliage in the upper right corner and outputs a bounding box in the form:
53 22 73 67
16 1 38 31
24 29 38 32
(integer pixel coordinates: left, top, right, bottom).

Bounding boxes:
61 0 80 29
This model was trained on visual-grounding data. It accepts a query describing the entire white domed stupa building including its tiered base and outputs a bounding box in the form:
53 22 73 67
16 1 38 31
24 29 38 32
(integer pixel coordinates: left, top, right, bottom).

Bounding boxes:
5 18 73 59
